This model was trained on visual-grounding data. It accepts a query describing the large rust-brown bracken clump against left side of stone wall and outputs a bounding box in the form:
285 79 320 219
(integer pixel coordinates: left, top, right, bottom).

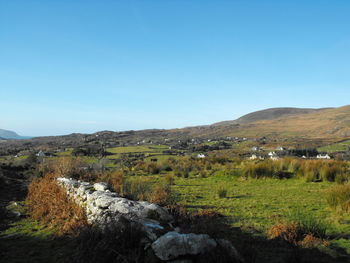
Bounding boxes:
26 174 87 235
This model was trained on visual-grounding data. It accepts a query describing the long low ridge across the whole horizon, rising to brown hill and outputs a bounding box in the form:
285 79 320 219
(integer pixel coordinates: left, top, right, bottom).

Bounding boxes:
0 105 350 153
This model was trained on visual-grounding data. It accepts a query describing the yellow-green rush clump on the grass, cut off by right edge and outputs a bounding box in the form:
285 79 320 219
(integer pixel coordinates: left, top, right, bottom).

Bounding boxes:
327 184 350 212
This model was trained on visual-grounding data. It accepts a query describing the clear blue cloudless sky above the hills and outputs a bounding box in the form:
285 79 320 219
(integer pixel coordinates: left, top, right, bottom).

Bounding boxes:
0 0 350 136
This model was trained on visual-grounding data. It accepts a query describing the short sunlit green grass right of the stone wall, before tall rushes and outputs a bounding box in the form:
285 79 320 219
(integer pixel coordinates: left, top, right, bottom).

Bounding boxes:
126 175 350 260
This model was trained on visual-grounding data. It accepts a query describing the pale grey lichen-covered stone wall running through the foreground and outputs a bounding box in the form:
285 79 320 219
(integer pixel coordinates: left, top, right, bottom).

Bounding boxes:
57 178 242 262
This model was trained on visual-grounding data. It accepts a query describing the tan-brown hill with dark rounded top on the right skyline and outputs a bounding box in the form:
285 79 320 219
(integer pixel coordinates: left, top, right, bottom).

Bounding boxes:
212 105 350 141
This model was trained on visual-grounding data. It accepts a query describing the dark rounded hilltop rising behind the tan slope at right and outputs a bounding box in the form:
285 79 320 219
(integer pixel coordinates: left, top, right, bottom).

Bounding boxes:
213 107 331 126
